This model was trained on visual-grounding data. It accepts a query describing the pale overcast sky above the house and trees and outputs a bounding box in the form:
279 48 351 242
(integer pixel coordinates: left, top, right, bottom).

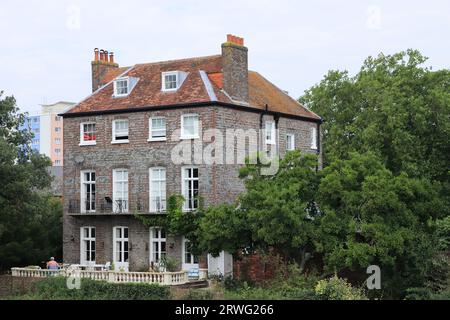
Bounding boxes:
0 0 450 114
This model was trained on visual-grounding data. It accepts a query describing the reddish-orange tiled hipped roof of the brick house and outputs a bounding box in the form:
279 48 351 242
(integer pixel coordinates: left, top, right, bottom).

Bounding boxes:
65 55 320 120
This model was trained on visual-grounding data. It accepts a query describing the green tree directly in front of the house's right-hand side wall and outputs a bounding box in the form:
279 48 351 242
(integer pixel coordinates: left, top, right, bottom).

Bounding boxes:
198 151 318 267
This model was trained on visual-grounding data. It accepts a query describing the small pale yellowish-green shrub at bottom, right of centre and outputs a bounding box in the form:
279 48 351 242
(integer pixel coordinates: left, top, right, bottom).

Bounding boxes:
315 276 367 300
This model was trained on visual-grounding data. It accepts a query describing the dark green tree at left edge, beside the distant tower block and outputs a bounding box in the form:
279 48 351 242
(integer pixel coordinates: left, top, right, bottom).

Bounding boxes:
0 92 62 270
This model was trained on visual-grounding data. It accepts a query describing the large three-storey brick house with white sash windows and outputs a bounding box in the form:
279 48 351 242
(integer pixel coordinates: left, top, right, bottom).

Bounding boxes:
62 35 321 271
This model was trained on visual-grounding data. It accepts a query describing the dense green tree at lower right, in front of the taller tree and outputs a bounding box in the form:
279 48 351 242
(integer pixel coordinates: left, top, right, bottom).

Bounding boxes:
315 153 445 297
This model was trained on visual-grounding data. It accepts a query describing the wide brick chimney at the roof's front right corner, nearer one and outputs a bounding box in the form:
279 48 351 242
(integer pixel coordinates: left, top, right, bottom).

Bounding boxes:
222 34 248 103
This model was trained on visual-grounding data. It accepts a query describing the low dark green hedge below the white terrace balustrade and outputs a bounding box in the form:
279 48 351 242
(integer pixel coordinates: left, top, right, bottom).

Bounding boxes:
29 277 170 300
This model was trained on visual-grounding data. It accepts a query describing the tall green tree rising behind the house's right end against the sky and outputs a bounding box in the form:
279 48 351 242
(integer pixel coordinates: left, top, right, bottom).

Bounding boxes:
299 50 450 185
